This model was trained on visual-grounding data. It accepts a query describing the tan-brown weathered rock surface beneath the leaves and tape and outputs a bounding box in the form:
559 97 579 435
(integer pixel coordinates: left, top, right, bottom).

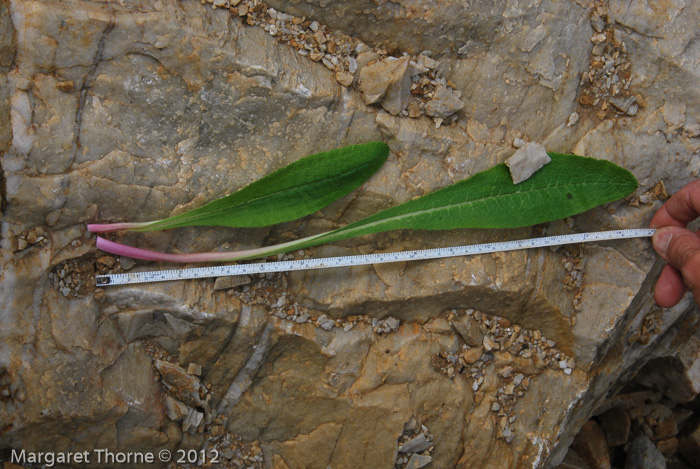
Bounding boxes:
0 0 700 468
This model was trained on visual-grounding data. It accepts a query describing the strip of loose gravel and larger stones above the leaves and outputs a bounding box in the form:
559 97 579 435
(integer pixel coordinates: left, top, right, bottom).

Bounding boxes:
203 0 464 127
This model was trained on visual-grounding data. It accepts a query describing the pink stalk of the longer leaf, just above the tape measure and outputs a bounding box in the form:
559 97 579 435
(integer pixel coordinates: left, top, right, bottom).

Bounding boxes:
97 236 282 262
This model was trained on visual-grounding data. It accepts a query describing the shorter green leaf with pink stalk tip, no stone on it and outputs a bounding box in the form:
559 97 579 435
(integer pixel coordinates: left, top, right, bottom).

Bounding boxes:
88 142 389 232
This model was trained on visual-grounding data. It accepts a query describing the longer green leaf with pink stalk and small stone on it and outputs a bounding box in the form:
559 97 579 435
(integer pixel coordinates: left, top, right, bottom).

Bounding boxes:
98 153 637 262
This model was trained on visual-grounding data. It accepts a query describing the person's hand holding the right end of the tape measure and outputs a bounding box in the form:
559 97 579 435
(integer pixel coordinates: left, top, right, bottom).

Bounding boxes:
650 179 700 308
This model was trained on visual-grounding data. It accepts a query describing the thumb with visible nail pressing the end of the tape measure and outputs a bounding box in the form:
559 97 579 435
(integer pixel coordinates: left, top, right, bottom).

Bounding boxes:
653 226 700 299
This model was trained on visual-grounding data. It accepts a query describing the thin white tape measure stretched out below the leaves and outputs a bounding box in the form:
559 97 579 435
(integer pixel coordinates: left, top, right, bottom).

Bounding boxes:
95 228 656 287
